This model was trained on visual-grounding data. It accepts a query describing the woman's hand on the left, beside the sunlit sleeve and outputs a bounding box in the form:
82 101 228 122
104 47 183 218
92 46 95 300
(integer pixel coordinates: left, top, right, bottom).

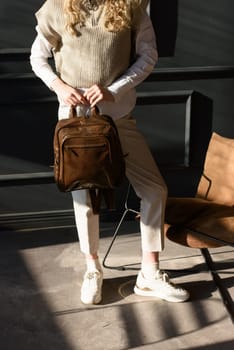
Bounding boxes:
51 78 88 106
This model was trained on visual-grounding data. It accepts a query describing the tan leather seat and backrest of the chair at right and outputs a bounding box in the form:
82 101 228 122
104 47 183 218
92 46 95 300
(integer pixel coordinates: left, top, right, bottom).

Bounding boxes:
165 133 234 248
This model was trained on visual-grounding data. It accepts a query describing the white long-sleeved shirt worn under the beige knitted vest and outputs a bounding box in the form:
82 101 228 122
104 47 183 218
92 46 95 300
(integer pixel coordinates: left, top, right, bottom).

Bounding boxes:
30 13 158 119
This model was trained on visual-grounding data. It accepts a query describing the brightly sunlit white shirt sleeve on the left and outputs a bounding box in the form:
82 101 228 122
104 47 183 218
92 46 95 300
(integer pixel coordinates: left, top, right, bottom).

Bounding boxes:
30 27 58 89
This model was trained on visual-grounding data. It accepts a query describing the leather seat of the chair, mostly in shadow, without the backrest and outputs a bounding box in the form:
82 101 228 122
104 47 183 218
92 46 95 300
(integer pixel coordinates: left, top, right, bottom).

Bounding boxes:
166 198 234 248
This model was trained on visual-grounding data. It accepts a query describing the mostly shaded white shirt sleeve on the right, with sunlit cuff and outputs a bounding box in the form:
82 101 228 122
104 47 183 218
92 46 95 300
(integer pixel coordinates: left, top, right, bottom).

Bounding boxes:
108 13 158 101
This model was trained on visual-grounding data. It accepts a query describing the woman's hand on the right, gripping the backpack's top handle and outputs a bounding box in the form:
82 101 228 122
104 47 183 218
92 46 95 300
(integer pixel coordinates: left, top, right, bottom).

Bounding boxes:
84 84 115 107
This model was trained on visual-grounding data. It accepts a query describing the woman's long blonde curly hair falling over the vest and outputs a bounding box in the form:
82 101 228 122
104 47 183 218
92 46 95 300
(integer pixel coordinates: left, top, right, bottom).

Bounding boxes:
64 0 141 35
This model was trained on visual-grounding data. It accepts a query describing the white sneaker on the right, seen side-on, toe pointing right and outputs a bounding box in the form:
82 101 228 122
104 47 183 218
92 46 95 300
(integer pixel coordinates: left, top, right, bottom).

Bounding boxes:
134 271 189 303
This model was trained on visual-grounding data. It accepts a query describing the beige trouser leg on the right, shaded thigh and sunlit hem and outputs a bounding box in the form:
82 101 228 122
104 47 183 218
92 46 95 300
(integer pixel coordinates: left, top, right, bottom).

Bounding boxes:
116 117 167 252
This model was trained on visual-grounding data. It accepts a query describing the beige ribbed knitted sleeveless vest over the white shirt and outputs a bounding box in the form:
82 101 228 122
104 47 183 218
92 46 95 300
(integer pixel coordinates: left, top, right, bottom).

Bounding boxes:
36 0 135 88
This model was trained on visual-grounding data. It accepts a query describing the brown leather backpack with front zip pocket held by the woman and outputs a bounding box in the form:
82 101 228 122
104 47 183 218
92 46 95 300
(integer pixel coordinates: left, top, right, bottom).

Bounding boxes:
54 108 125 213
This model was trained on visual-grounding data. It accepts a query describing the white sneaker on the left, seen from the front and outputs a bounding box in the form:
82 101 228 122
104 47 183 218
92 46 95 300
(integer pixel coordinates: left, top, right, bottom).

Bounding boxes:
80 270 103 304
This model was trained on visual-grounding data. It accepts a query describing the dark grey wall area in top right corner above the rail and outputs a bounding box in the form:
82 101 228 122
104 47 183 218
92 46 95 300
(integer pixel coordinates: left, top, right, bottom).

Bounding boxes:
168 0 234 66
